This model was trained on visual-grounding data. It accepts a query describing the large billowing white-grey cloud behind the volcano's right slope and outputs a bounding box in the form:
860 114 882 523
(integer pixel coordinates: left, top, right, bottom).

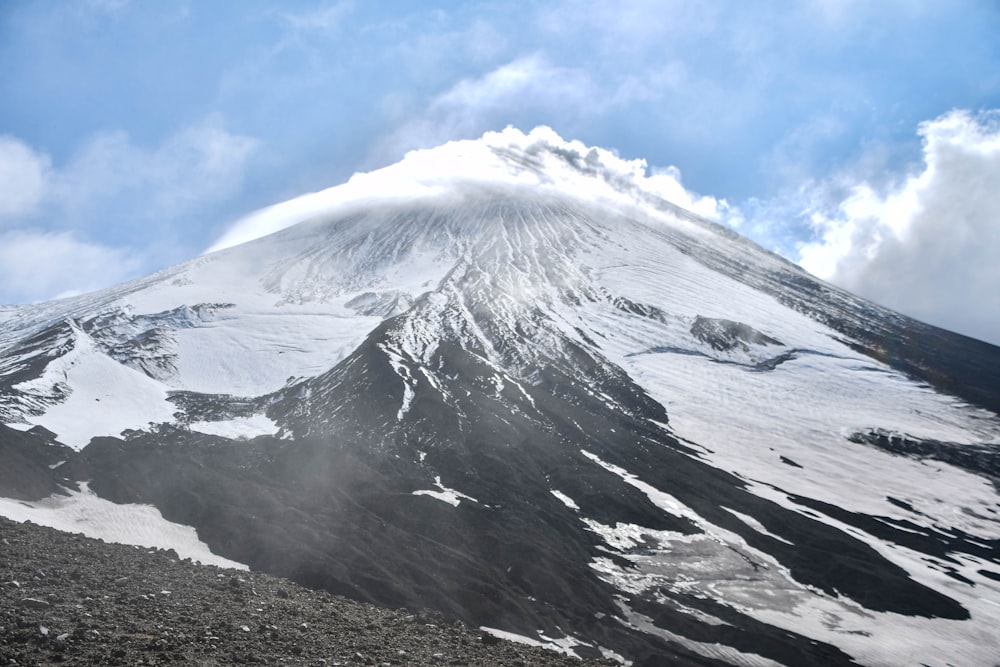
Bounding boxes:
800 111 1000 344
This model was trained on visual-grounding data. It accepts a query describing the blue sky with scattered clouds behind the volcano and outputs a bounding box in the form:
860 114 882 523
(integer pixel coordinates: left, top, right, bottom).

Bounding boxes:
0 0 1000 343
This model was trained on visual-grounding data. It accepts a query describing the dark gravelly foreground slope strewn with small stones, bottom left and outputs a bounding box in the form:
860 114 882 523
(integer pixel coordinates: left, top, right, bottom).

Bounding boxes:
0 518 614 666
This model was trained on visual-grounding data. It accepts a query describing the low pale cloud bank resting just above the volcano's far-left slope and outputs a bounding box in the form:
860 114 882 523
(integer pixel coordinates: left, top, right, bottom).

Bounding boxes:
0 231 139 303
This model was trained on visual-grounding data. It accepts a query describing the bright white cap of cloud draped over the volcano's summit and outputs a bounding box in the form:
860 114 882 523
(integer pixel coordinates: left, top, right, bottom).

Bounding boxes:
209 126 724 252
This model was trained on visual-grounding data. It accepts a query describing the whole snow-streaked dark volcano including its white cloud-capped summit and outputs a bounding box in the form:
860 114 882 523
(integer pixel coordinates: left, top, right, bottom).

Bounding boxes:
0 130 1000 665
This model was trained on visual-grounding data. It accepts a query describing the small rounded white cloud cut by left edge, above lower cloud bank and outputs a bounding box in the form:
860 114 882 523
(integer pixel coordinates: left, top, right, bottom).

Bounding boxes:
0 135 52 224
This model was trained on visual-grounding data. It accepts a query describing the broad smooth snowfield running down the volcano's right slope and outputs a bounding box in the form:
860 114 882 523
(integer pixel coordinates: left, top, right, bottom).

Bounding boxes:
560 217 1000 532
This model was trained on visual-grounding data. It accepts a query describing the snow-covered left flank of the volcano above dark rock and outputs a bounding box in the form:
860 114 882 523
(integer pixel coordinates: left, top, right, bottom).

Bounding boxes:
0 204 462 447
